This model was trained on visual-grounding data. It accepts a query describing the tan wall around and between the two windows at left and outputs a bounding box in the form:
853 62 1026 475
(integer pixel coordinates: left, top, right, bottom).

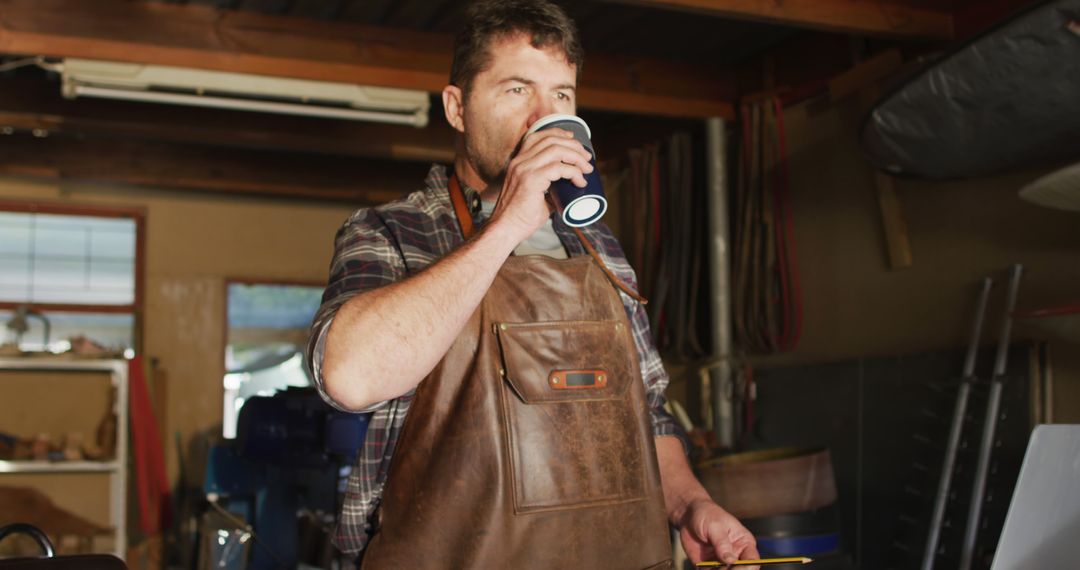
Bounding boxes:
0 178 353 484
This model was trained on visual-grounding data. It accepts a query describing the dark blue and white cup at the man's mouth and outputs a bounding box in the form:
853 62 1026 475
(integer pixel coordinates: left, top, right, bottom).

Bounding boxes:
526 114 607 228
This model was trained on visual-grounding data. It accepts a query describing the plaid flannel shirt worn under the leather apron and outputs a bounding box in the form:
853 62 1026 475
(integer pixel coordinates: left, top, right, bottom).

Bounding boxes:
307 165 684 554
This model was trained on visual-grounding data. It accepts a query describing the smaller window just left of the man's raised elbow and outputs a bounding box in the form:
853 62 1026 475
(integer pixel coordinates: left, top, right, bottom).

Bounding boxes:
221 282 323 438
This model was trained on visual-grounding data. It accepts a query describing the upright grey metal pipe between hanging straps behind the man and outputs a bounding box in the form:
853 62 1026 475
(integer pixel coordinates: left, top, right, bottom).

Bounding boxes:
705 117 734 448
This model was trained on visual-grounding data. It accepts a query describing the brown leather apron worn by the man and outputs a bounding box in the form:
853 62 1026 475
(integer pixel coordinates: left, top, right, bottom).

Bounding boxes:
363 181 672 570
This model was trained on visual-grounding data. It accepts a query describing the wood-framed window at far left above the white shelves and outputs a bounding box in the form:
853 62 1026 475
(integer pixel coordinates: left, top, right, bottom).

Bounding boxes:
0 202 145 353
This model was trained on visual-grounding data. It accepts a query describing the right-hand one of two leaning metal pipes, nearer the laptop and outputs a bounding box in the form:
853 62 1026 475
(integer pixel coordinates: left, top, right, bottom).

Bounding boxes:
960 263 1024 570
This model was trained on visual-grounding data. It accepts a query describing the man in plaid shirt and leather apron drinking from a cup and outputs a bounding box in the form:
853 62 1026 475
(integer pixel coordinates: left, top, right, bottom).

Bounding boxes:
309 0 757 569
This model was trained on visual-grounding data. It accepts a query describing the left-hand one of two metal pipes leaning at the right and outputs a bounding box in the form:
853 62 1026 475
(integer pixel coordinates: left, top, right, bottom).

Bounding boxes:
922 277 994 570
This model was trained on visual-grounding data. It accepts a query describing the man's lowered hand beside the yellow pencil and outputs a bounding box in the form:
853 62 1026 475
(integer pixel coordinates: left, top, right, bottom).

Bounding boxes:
679 499 758 564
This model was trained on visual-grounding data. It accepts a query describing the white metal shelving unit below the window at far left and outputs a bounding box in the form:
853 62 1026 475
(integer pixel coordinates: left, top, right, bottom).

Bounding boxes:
0 357 127 560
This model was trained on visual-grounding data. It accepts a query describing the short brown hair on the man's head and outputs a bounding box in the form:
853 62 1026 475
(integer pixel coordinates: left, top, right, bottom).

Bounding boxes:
450 0 585 93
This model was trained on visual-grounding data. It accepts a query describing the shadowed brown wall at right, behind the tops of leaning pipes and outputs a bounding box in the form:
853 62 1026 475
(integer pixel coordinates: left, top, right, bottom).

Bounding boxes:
758 103 1080 423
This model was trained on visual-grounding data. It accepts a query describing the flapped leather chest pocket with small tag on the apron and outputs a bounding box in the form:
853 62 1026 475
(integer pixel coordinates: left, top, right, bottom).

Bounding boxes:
495 321 649 513
